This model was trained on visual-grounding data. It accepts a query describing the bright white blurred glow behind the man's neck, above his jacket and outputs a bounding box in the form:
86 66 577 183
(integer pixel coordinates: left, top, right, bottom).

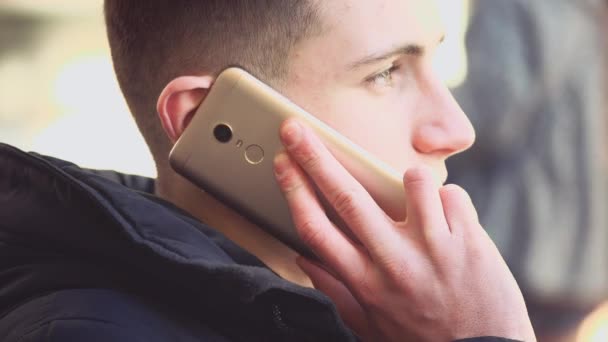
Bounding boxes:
32 56 156 176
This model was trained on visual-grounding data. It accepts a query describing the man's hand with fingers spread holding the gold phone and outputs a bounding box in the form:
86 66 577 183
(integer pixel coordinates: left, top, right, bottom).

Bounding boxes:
275 120 535 341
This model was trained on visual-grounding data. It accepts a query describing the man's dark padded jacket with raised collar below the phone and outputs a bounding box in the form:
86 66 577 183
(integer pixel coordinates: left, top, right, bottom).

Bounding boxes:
0 144 524 342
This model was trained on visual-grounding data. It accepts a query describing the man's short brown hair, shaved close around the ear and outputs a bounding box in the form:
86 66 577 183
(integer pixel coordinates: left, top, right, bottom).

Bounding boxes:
104 0 320 167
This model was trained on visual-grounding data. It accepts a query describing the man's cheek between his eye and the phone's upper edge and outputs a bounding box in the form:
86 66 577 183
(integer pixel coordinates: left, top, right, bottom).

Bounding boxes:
282 82 422 172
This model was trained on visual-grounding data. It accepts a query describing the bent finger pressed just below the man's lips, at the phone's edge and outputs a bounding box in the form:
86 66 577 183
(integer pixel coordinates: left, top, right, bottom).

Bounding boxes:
403 168 449 237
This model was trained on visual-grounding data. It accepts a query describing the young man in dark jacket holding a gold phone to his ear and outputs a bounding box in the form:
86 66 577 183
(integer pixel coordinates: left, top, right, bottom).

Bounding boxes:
0 0 534 341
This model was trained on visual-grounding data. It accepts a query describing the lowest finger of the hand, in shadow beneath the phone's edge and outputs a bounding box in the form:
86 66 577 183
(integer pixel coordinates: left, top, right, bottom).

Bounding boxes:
297 258 370 337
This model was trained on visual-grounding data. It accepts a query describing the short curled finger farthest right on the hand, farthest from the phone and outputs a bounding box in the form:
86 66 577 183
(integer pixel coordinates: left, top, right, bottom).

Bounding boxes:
439 184 481 235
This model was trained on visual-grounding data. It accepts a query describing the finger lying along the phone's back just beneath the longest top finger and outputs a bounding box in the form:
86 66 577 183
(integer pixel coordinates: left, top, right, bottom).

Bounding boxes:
274 153 366 281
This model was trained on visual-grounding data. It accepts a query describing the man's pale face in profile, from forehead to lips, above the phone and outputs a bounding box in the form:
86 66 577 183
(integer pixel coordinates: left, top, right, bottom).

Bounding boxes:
282 0 474 181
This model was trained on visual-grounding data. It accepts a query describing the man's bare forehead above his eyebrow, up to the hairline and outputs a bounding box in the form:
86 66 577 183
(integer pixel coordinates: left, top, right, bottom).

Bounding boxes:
291 0 444 81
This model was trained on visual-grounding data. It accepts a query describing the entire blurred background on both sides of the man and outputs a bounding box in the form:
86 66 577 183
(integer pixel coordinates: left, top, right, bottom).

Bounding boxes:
0 0 608 342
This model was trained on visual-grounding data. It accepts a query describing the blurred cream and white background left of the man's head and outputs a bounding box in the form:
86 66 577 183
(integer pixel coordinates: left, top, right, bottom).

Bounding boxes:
0 0 156 176
